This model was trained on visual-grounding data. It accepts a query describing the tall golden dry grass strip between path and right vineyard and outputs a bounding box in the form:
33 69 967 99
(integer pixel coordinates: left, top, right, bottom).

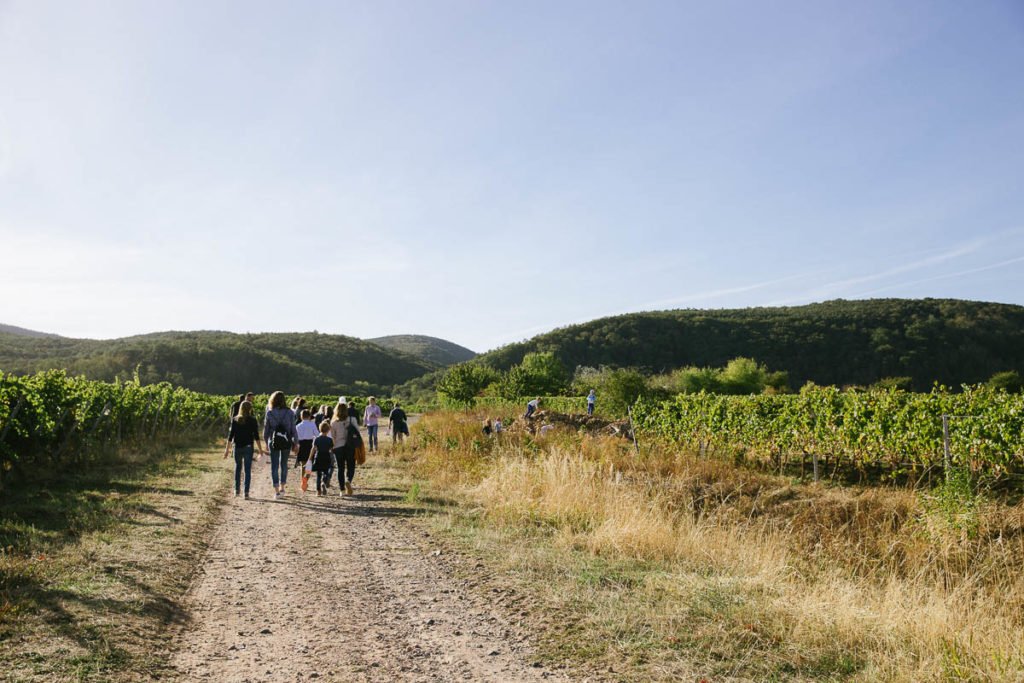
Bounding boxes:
395 414 1024 681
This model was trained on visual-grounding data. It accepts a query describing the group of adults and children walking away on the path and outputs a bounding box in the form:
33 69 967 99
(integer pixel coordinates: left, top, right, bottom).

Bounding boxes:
224 391 409 499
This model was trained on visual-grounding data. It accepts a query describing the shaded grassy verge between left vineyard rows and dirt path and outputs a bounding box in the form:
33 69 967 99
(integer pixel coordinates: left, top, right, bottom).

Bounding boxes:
0 444 229 681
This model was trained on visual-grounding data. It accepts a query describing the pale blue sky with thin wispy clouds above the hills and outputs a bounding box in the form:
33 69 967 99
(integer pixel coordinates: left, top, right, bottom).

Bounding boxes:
0 0 1024 351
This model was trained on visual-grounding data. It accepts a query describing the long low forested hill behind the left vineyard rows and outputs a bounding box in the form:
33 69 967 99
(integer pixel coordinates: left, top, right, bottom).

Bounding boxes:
0 332 439 394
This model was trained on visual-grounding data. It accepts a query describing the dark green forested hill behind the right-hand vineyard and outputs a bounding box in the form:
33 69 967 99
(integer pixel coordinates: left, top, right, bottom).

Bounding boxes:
478 299 1024 389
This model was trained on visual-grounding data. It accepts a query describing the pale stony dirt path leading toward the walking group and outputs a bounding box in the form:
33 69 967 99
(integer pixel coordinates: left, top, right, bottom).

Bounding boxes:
167 432 567 682
